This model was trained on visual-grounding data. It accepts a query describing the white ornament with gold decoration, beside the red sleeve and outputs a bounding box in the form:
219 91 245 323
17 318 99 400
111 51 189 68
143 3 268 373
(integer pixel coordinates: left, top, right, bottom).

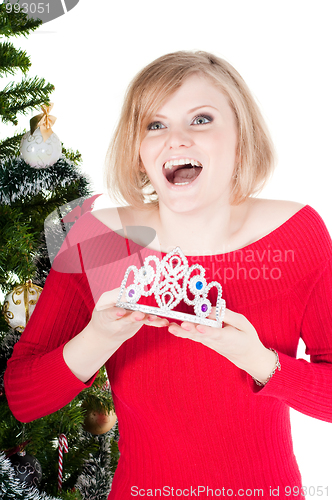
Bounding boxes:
2 280 43 332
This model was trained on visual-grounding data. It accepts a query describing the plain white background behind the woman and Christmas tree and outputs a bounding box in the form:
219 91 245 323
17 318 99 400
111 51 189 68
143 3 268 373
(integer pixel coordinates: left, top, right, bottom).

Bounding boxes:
1 0 332 498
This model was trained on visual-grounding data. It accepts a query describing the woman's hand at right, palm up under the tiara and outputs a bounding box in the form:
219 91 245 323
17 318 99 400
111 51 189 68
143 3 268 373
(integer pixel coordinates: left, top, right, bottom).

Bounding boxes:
168 307 276 383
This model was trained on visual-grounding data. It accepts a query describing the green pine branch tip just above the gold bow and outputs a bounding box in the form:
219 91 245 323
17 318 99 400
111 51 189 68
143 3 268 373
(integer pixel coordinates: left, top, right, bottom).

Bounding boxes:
0 77 54 125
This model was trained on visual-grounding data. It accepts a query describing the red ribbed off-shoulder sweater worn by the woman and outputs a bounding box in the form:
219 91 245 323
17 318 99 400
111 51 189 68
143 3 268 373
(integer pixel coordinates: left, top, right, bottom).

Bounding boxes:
5 202 332 500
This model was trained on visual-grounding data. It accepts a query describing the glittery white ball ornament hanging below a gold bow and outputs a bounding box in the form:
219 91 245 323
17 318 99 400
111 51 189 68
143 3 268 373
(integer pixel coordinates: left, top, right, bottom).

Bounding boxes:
20 128 62 168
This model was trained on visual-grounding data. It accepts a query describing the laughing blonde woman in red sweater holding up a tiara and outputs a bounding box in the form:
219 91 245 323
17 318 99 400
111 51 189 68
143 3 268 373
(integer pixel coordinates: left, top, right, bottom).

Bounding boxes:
6 52 332 500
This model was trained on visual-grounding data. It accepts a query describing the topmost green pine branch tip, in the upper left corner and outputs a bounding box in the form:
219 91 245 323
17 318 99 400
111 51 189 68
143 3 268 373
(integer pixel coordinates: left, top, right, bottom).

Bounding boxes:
0 2 43 37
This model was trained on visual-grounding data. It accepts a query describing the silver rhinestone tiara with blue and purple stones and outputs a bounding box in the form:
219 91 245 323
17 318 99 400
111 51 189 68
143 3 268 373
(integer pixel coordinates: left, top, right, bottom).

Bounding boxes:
116 247 226 328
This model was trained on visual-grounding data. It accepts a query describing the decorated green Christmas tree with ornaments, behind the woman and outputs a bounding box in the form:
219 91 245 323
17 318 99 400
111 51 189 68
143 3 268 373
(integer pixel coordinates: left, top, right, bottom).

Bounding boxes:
0 3 119 500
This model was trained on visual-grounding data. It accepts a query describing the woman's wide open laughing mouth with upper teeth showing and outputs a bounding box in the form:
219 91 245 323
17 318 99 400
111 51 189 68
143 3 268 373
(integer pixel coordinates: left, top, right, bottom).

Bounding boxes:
163 158 203 186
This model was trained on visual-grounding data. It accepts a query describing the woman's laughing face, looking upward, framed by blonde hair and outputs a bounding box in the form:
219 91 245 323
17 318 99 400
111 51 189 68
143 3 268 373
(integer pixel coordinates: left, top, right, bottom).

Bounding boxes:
140 75 238 212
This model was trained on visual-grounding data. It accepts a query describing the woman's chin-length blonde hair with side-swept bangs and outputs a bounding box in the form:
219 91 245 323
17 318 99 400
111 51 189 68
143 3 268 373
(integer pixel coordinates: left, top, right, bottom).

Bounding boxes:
106 51 275 208
